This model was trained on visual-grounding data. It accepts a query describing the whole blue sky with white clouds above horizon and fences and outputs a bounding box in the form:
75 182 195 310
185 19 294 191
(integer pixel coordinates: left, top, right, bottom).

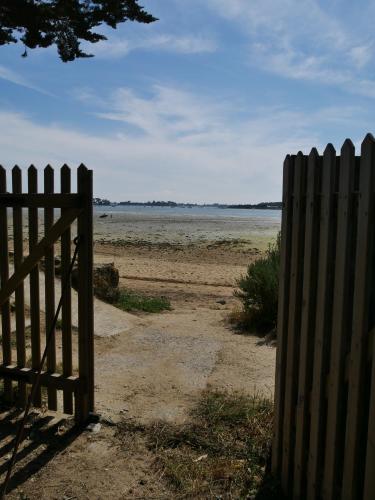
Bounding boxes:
0 0 375 203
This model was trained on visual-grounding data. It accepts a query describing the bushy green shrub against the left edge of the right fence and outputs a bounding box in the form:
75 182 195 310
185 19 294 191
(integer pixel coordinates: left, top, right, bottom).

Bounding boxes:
235 233 280 332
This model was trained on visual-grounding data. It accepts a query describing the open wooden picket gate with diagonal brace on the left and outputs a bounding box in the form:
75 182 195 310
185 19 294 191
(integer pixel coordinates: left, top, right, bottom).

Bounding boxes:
0 165 94 422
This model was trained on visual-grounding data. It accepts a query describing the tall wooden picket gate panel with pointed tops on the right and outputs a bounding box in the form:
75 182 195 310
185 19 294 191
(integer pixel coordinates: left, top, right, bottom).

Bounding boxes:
272 134 375 500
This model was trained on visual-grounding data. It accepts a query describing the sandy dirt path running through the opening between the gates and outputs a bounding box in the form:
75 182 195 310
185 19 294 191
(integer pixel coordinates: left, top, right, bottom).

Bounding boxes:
96 300 275 422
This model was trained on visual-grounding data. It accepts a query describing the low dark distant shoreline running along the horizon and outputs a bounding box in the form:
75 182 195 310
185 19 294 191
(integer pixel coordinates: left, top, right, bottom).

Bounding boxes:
93 198 282 210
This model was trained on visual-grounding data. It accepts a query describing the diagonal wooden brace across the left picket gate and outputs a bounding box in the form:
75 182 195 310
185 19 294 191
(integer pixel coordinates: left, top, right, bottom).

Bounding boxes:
0 208 82 306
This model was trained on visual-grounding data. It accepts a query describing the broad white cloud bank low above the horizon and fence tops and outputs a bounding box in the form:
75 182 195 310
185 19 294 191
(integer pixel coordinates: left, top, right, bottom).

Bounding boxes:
0 85 370 202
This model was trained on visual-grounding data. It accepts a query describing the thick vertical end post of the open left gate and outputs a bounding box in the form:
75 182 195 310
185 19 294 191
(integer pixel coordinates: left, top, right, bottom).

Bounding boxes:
76 165 94 421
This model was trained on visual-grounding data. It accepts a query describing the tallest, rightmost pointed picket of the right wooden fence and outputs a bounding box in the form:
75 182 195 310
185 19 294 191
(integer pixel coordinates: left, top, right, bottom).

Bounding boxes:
342 134 375 500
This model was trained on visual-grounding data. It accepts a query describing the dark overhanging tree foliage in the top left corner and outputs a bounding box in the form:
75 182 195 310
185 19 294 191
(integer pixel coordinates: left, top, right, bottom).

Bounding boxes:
0 0 157 62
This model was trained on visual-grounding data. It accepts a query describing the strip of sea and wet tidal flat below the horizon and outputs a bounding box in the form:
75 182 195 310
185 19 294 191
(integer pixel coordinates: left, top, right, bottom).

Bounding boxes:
94 206 281 246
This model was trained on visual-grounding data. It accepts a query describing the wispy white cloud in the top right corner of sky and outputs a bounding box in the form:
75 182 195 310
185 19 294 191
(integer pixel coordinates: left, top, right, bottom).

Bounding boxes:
208 0 375 97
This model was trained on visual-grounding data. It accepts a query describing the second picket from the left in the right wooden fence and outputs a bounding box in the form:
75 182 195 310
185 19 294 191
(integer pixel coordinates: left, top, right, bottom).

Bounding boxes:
281 152 307 496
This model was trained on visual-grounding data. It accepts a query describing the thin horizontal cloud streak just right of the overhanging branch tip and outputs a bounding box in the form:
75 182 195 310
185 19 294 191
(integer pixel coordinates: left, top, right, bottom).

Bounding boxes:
90 34 217 59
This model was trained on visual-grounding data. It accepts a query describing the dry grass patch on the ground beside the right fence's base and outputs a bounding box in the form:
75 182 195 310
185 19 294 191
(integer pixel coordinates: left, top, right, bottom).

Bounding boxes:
117 391 281 499
